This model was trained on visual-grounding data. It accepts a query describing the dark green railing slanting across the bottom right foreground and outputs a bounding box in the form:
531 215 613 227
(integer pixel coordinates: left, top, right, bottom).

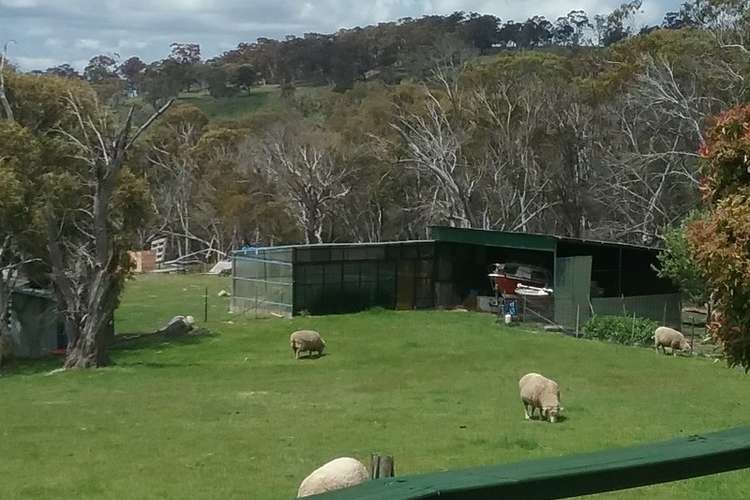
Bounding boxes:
309 427 750 500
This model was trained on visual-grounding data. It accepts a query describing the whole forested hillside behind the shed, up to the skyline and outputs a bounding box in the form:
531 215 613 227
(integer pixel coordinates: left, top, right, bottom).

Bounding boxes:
6 0 748 255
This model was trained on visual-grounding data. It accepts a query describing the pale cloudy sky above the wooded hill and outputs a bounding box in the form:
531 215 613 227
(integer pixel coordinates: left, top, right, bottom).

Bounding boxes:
0 0 681 70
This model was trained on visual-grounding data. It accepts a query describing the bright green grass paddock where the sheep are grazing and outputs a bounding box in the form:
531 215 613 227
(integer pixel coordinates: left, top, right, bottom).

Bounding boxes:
0 276 750 499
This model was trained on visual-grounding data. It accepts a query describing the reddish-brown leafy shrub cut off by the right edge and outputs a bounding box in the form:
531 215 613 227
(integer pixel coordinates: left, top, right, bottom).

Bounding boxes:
687 106 750 371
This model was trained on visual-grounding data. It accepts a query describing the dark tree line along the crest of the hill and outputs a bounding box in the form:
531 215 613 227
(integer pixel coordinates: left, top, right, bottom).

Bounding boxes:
39 0 716 100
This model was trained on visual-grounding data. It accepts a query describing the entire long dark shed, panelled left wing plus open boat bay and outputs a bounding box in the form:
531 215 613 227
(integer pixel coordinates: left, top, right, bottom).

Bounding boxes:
232 226 680 328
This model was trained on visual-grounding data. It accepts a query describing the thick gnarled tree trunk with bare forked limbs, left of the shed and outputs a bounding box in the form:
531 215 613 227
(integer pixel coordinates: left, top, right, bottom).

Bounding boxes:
53 96 172 368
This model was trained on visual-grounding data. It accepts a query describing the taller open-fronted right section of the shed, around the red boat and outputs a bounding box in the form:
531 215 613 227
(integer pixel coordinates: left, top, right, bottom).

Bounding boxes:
431 227 680 328
